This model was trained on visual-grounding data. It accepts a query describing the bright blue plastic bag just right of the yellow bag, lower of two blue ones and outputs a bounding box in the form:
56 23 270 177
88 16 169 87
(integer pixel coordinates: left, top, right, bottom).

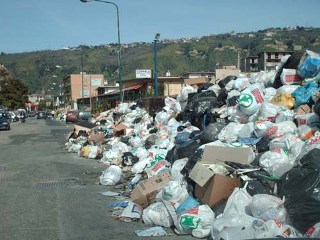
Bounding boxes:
291 82 318 108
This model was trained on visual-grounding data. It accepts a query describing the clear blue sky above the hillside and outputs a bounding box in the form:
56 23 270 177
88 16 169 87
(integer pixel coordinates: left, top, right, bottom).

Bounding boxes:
0 0 320 53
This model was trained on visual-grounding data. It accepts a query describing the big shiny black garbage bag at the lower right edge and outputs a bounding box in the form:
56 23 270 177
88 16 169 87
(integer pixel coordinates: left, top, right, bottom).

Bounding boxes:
279 149 320 233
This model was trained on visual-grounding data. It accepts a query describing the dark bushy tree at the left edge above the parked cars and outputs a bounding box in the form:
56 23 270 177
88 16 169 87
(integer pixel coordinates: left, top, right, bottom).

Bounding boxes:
0 79 28 110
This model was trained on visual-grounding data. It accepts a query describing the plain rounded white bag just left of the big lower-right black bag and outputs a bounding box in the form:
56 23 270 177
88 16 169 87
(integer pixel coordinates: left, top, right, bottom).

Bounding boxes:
249 194 287 222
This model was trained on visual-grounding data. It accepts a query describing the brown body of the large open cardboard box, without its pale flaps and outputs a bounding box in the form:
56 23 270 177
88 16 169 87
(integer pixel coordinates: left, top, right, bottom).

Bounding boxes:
194 174 240 207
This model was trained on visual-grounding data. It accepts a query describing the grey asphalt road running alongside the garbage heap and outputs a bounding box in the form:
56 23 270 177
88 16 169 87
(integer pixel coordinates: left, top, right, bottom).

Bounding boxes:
0 118 192 240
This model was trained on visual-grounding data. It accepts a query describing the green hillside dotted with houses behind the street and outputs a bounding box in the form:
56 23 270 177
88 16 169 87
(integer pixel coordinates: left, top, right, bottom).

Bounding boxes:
0 27 320 93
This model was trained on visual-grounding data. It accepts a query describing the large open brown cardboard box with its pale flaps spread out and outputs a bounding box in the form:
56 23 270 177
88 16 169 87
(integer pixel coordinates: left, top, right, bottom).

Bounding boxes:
189 146 250 207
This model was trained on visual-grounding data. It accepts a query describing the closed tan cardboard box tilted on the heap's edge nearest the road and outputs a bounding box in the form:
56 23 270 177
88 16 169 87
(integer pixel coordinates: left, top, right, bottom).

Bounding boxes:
131 172 171 208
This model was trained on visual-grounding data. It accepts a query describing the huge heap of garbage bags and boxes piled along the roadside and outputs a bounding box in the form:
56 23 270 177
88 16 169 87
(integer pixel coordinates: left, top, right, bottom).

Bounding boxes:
66 51 320 239
